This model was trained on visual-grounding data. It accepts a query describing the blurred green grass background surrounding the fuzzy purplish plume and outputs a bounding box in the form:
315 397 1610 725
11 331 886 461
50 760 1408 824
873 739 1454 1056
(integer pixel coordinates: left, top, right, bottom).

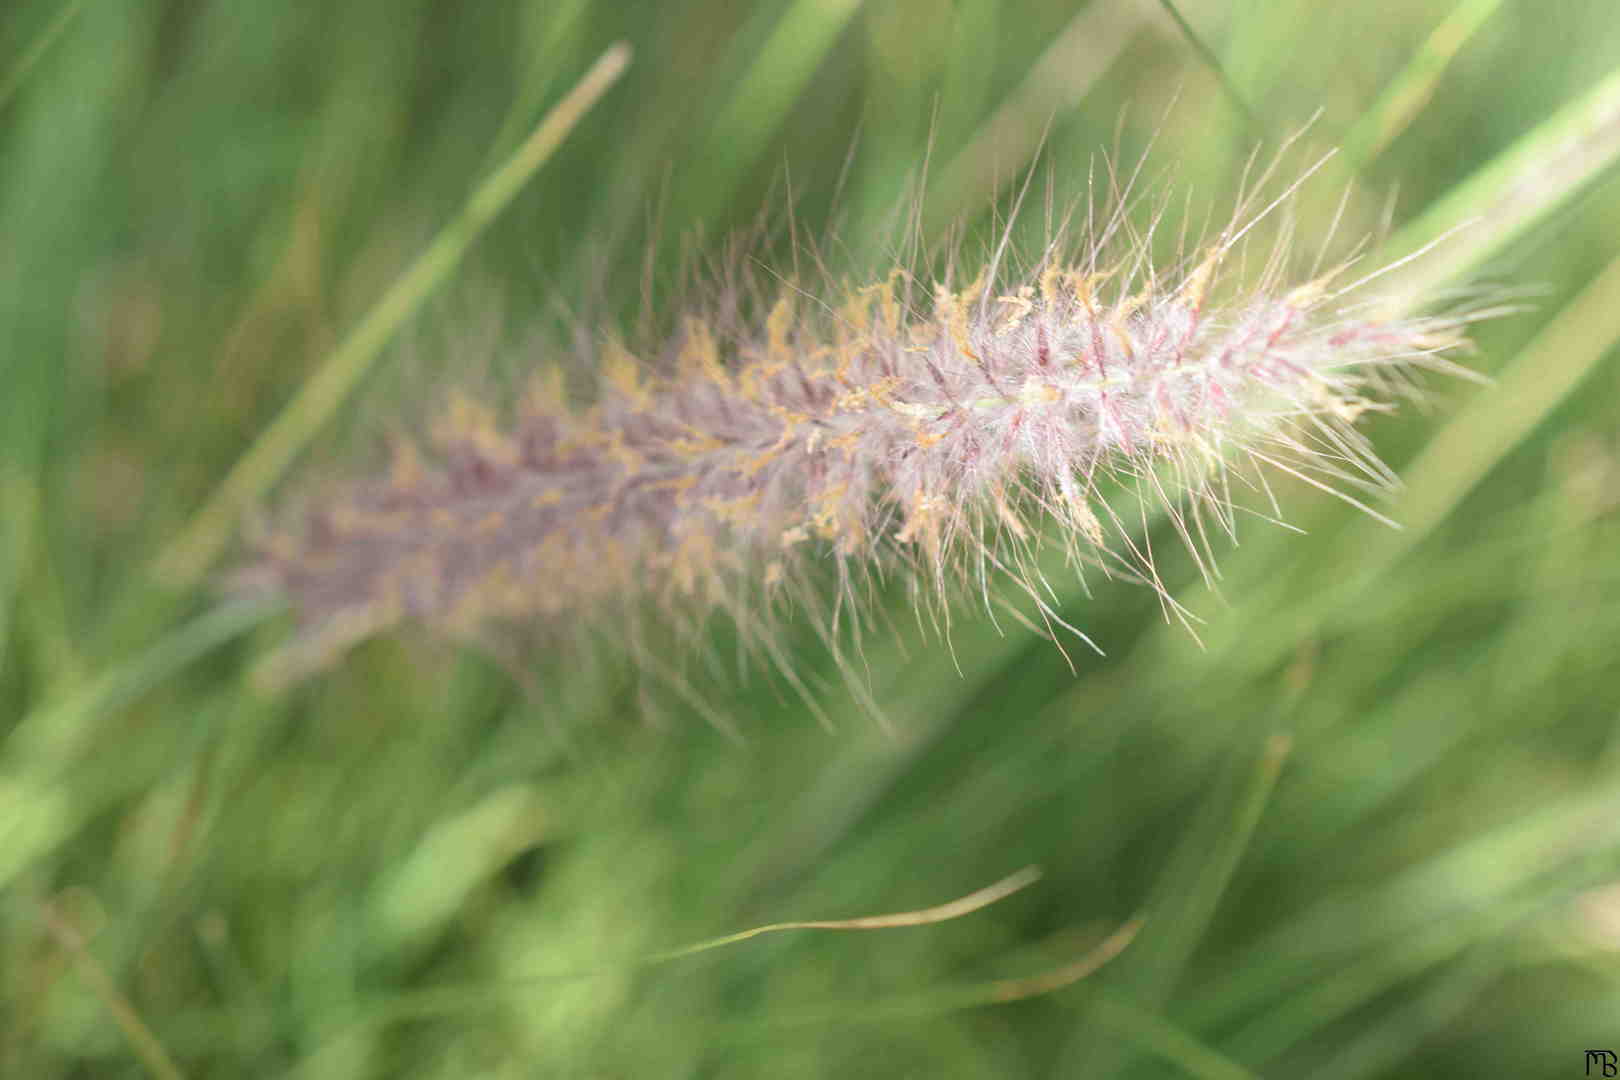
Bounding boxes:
0 0 1620 1080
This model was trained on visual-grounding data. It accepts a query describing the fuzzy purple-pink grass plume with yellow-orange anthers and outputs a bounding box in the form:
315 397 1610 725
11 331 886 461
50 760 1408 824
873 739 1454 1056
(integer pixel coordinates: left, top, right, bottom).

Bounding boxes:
245 156 1468 689
